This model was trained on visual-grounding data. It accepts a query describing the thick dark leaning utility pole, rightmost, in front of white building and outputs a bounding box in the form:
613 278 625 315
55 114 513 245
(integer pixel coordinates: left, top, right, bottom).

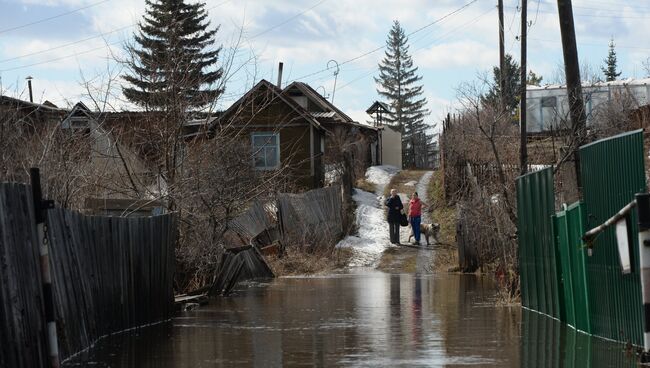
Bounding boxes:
557 0 587 192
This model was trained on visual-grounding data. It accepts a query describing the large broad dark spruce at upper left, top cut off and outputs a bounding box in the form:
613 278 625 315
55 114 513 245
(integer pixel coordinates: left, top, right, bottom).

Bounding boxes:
122 0 223 111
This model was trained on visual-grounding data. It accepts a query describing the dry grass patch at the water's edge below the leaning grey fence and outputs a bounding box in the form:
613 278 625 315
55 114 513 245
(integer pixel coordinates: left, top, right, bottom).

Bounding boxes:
266 246 352 276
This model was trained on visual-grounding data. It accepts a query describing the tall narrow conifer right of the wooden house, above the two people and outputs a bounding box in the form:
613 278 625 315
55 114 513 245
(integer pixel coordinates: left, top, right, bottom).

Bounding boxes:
375 21 429 167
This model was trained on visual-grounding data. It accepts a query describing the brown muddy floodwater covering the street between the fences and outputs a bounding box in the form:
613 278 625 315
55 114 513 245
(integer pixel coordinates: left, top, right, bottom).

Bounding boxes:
64 270 636 368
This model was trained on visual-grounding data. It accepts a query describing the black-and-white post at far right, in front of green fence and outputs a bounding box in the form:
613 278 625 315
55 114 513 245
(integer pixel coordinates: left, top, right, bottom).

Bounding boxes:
636 193 650 363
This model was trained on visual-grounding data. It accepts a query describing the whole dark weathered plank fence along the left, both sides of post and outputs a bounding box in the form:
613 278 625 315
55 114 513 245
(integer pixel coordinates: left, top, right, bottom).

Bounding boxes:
0 184 176 367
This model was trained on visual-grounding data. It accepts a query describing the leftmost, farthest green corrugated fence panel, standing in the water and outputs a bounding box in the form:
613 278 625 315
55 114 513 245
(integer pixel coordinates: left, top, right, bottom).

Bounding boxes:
517 168 561 318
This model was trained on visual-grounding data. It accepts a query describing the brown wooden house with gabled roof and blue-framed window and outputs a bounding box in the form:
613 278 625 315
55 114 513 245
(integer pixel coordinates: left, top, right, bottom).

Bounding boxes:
211 80 378 189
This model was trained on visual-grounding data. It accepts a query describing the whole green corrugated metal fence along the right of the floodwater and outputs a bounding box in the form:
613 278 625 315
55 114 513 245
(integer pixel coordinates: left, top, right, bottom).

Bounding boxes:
517 131 646 345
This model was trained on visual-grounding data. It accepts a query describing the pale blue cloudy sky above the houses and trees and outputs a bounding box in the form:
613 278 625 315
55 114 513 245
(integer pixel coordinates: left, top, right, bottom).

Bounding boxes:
0 0 650 127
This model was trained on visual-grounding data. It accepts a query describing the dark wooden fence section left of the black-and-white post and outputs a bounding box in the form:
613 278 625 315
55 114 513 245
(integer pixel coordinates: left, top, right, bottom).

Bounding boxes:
0 184 47 367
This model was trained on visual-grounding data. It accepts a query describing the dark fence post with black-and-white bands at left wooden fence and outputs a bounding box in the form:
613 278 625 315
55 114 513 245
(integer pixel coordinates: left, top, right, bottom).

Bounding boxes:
29 168 59 368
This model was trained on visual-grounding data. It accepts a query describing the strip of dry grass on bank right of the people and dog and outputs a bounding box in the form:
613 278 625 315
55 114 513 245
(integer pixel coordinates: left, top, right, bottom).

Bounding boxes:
427 170 458 272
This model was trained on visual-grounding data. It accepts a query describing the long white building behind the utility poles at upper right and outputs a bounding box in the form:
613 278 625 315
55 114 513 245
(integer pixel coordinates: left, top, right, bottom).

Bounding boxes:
526 78 650 133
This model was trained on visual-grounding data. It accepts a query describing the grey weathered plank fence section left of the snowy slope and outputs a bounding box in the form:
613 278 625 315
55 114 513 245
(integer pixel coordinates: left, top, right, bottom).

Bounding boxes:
278 186 343 246
